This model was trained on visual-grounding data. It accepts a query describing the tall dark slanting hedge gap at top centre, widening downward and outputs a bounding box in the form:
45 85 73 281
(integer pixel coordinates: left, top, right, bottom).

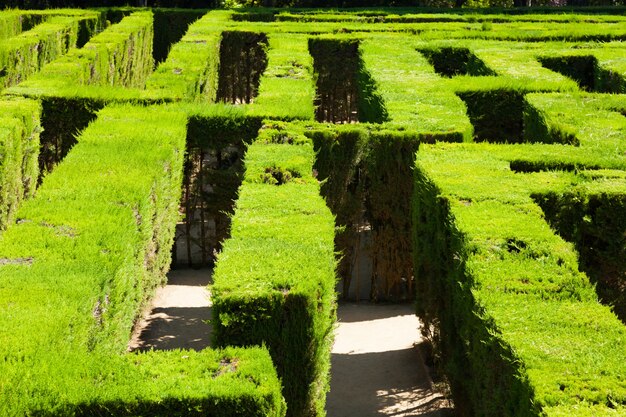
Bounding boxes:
309 38 388 123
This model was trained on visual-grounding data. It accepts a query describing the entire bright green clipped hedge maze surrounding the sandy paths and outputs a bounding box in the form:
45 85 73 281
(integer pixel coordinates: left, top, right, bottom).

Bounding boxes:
0 5 626 417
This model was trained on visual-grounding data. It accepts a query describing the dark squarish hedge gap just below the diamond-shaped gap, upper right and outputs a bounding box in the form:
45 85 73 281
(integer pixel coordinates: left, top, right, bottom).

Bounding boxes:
457 90 524 143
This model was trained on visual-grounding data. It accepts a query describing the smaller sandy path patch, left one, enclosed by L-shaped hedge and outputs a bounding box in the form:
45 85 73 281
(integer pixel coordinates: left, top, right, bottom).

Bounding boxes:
130 269 212 351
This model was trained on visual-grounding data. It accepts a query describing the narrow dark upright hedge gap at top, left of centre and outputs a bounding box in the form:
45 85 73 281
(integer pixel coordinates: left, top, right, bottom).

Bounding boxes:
217 31 268 104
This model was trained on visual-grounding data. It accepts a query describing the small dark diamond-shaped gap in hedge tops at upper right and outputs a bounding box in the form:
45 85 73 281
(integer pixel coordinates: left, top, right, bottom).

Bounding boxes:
418 47 496 78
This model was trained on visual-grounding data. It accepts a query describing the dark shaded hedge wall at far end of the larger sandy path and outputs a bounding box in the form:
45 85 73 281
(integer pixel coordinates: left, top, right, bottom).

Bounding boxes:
305 125 422 301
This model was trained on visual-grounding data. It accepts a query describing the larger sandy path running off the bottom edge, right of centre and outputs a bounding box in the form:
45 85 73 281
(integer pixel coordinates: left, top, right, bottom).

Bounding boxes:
326 303 453 417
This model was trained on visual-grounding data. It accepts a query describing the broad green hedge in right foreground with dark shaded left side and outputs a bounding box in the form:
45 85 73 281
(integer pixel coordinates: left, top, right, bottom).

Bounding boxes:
413 144 626 416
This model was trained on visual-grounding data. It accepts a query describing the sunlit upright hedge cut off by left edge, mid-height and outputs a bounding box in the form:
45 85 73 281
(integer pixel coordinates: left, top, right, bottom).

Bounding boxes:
0 99 41 229
